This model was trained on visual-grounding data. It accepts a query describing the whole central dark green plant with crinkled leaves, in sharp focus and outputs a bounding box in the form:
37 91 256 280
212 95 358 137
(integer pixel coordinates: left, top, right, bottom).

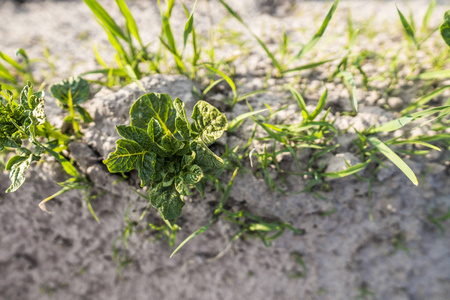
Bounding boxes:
104 93 228 220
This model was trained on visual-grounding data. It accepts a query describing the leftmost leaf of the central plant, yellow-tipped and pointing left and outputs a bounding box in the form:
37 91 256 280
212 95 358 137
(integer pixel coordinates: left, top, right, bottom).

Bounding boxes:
103 139 147 173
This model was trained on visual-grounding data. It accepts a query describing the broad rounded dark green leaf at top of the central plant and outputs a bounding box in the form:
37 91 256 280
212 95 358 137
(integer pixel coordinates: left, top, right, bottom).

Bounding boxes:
130 93 176 132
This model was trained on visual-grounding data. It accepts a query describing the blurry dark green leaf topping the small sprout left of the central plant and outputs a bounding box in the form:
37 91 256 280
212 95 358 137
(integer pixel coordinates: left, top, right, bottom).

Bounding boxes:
50 77 90 108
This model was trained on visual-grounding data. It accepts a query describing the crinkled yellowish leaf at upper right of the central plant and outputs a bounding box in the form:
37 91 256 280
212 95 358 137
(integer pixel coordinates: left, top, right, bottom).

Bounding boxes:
191 101 228 145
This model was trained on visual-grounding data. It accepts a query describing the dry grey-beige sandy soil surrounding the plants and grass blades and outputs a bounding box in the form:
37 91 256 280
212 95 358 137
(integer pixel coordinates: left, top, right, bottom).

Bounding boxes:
0 0 450 300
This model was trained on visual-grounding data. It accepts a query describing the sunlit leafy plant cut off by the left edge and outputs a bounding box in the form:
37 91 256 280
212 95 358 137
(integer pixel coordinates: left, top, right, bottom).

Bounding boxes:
0 83 99 222
